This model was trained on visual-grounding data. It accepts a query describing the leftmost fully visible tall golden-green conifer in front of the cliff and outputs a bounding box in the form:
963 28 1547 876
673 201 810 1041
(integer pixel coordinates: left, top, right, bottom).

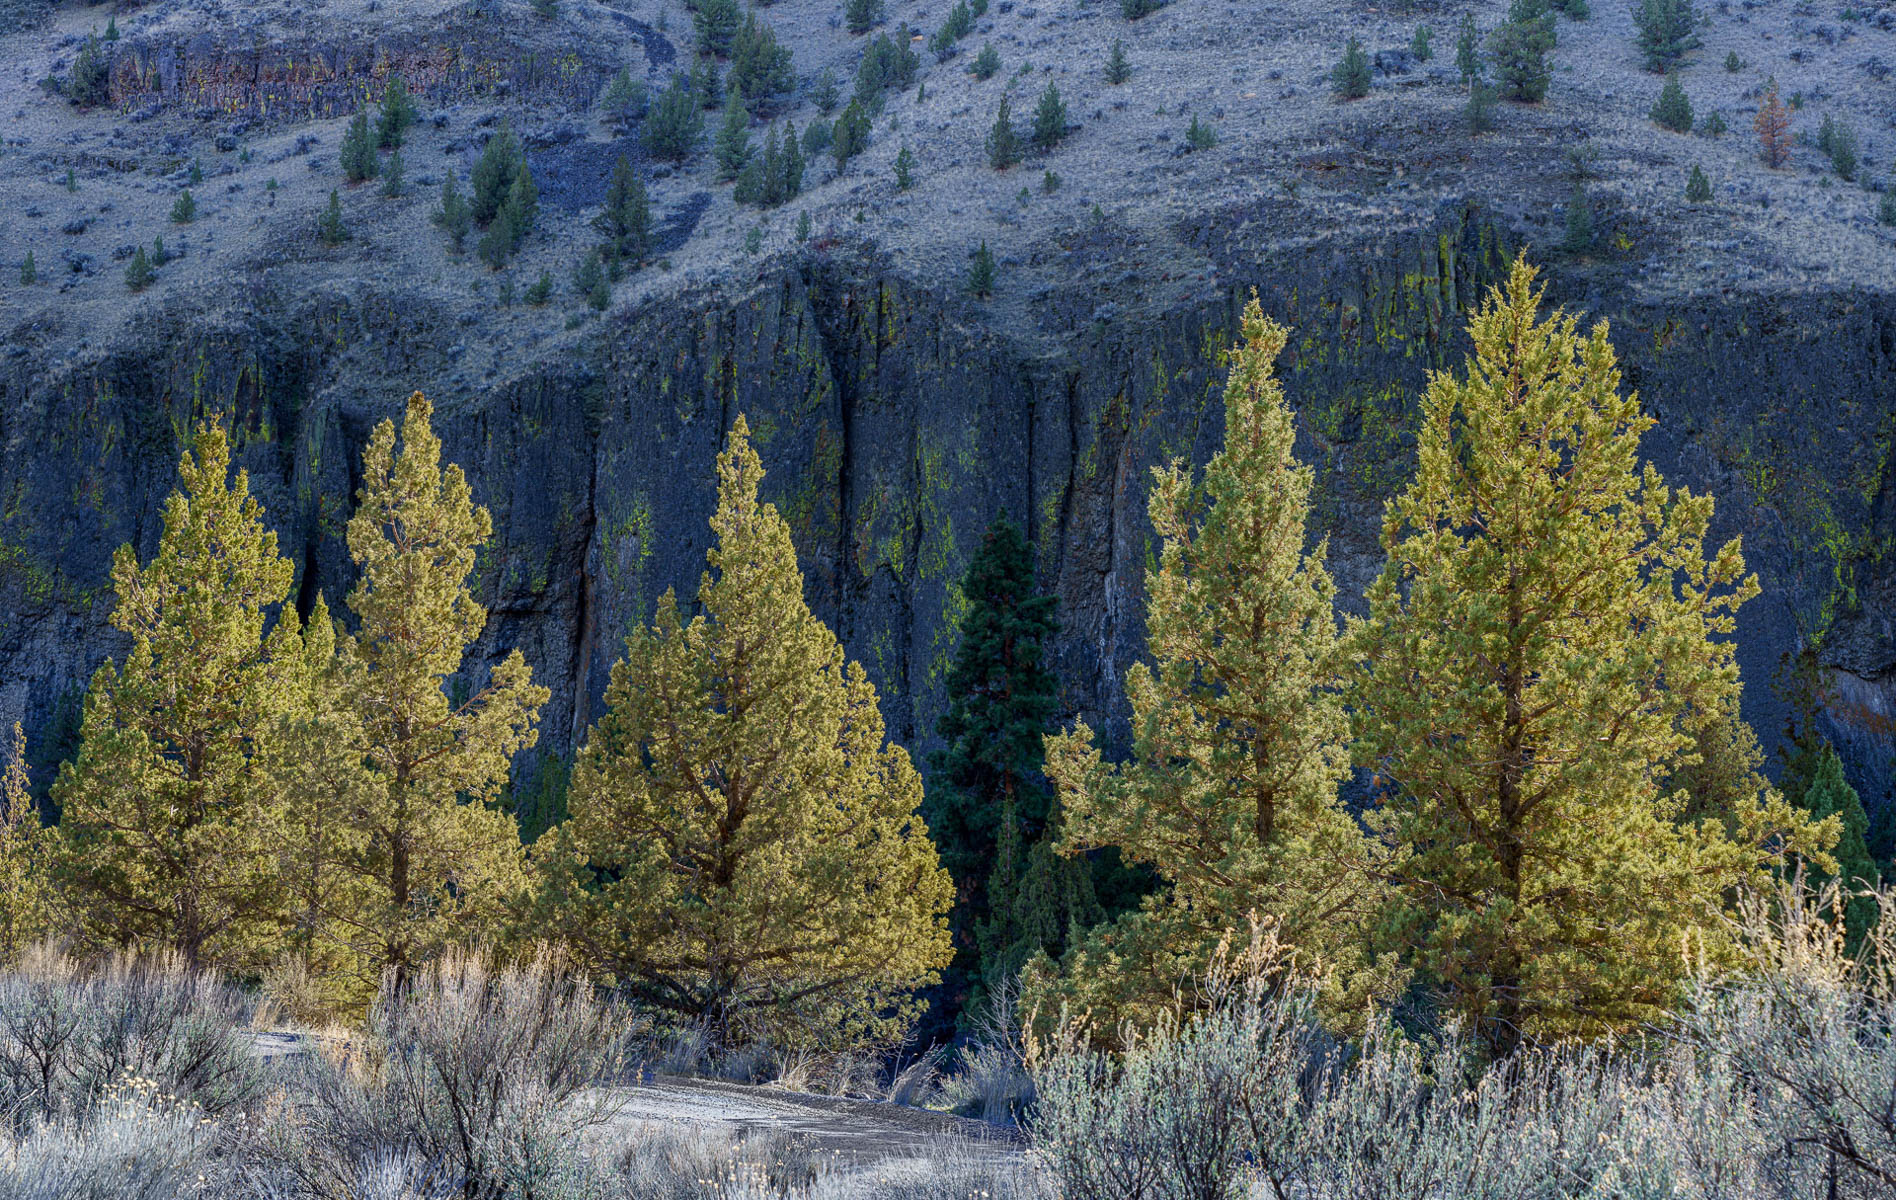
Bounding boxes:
53 423 296 969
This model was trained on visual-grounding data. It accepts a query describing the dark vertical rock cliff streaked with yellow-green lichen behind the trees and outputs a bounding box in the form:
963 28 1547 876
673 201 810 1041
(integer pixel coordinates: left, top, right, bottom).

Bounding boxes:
0 209 1896 818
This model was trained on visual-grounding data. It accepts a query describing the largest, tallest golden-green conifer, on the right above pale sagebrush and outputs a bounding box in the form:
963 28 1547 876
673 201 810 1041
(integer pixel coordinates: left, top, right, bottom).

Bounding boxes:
1348 260 1830 1054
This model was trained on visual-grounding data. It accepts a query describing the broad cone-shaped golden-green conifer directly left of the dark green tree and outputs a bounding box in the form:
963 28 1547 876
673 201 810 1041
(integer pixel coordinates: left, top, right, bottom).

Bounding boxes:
535 417 952 1046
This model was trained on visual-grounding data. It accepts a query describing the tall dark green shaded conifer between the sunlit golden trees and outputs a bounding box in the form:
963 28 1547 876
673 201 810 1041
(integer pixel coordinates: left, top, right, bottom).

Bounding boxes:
923 518 1100 1007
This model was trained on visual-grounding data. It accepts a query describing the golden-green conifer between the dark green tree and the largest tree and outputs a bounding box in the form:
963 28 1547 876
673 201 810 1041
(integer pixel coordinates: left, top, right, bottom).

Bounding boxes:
1047 296 1388 1022
